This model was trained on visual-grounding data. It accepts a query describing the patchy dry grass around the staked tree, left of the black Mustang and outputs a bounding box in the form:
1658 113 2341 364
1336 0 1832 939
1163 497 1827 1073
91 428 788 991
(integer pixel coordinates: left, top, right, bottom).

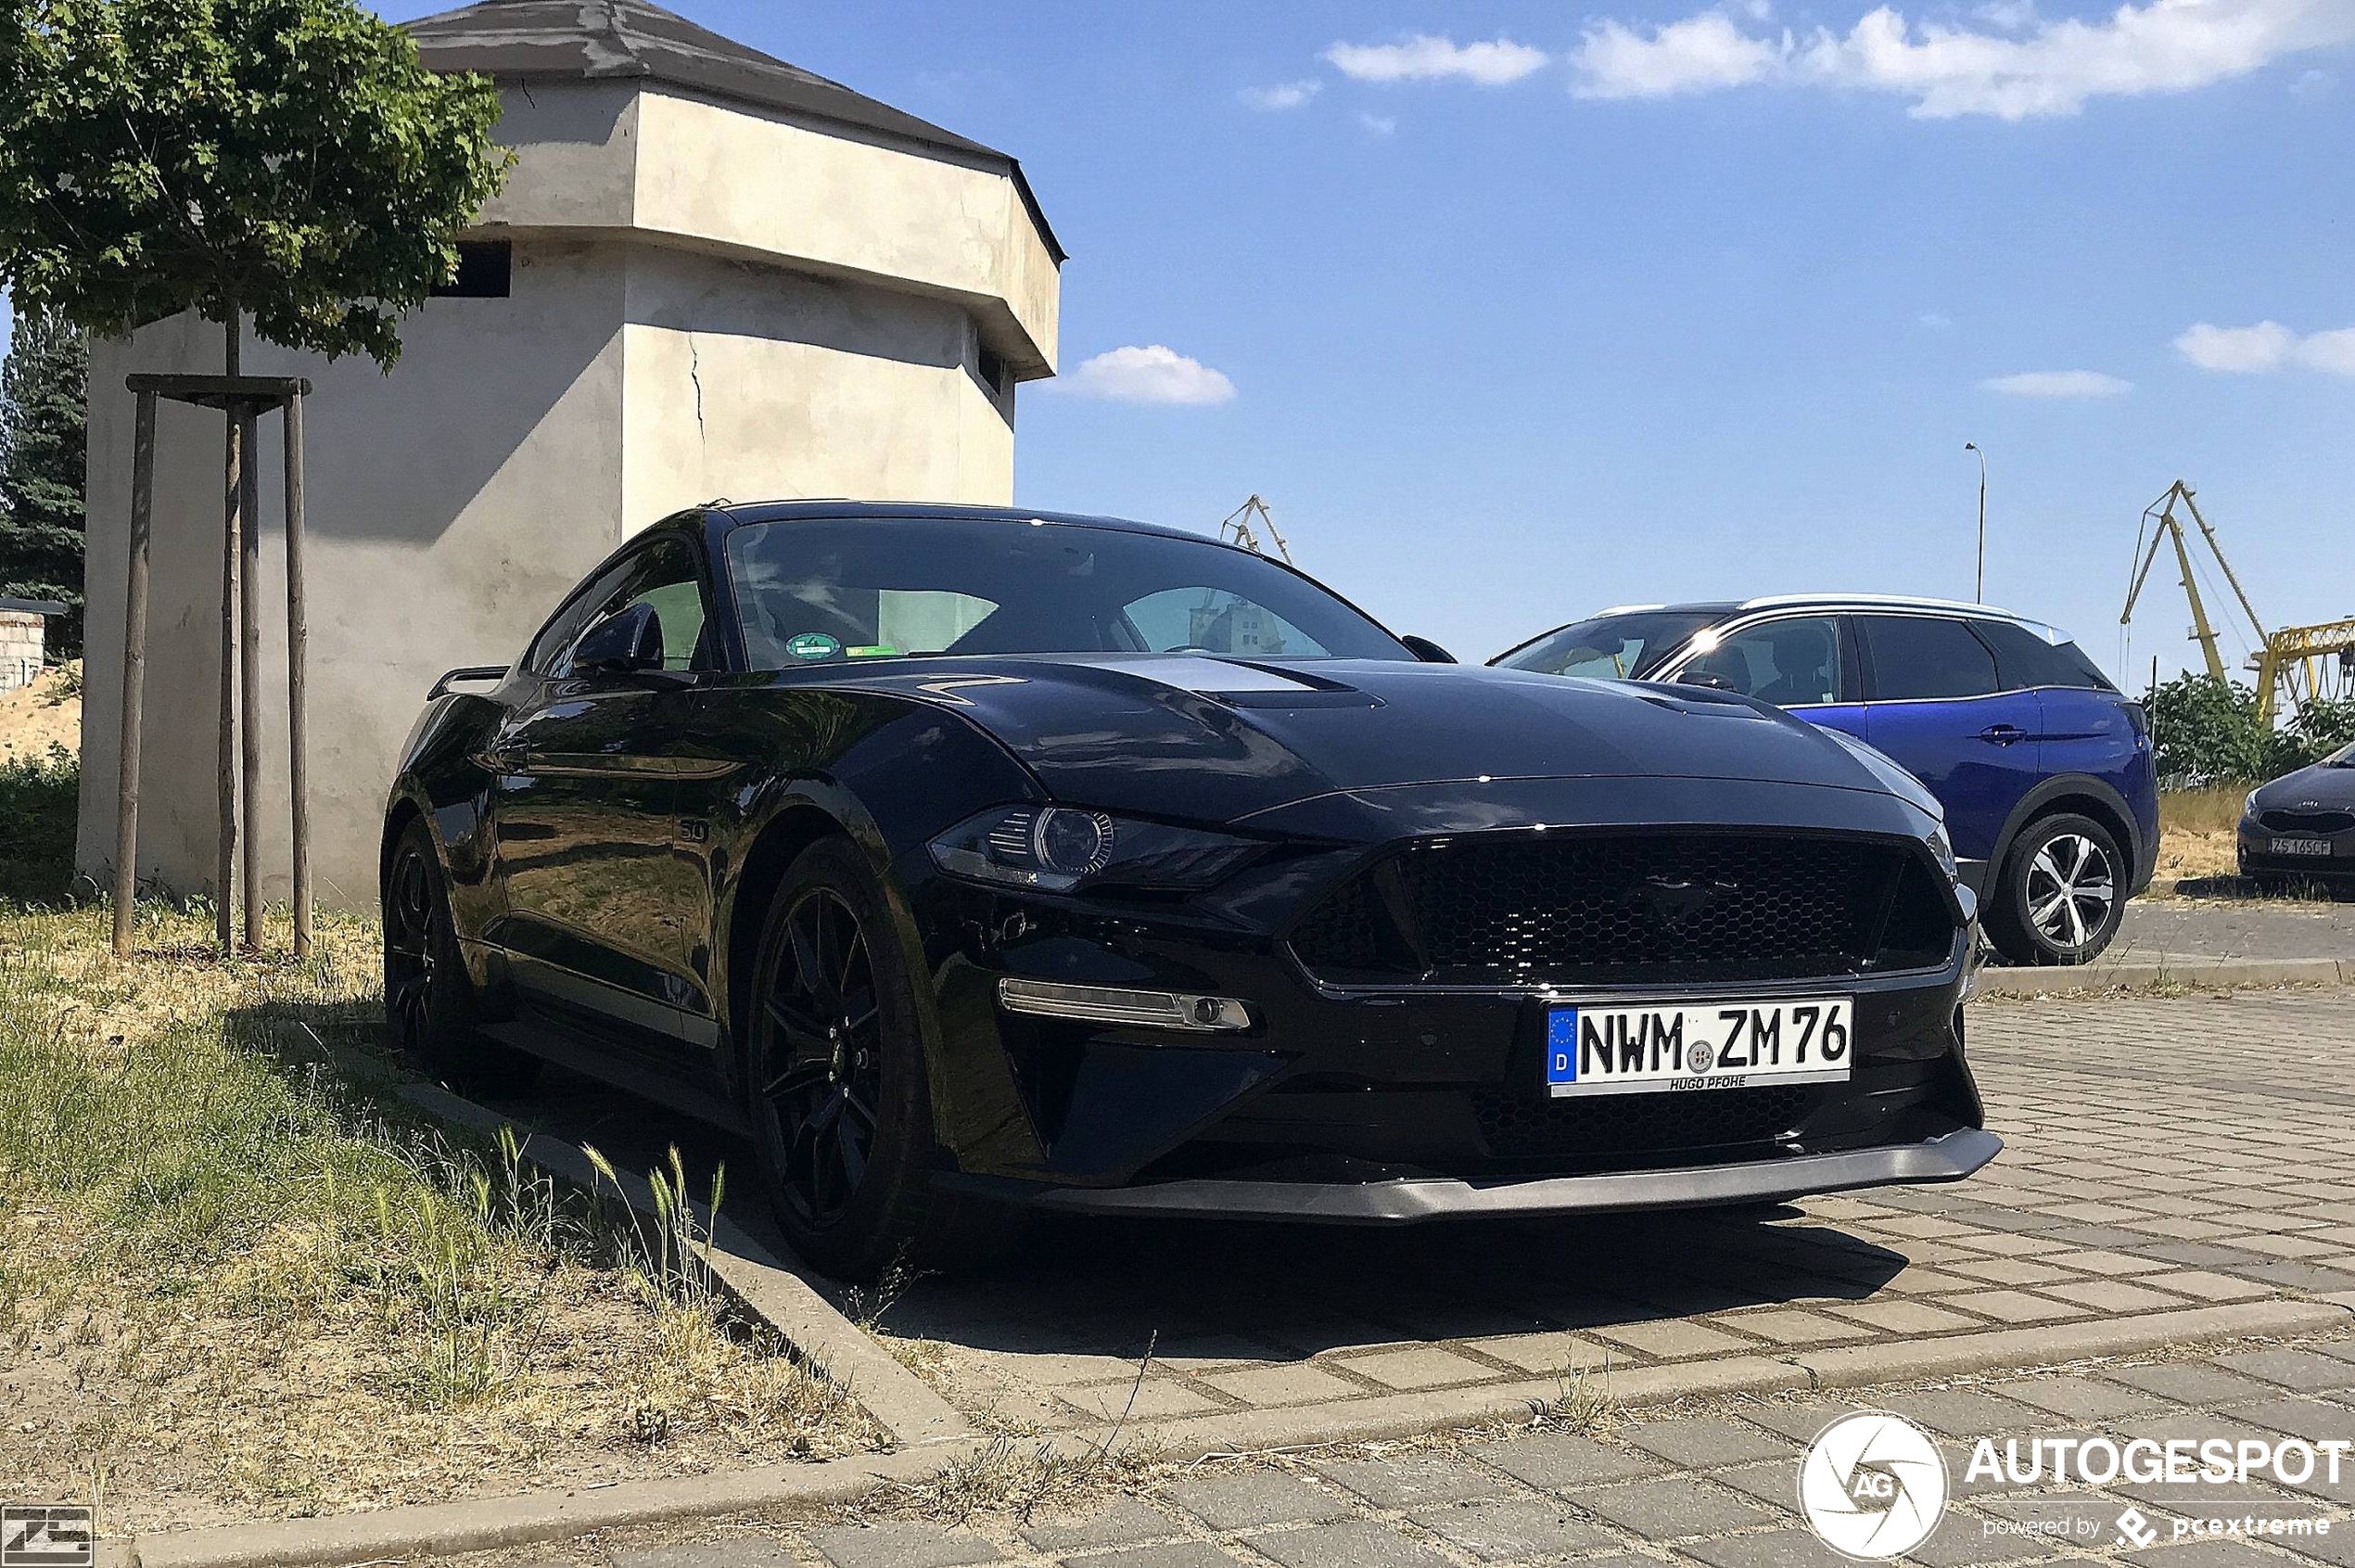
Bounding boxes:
0 907 884 1528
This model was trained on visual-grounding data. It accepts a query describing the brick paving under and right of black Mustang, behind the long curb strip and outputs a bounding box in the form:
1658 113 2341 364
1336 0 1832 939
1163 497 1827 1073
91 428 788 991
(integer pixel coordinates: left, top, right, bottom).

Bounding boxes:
861 991 2355 1427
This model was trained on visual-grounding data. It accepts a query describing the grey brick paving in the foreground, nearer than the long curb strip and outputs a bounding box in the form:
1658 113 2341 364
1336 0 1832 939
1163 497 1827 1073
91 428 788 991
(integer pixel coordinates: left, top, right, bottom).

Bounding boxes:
459 1337 2355 1568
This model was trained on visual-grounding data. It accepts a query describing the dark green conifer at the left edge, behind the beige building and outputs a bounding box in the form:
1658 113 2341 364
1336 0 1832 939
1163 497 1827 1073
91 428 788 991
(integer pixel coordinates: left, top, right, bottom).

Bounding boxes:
0 309 90 659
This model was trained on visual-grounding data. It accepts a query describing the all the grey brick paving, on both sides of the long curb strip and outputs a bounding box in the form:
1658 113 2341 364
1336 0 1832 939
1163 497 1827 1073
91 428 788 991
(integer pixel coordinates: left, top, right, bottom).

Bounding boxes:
419 991 2355 1568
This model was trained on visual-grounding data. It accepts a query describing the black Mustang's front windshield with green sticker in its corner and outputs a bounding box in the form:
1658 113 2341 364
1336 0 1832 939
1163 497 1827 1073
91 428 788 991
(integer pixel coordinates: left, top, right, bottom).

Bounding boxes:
728 518 1416 669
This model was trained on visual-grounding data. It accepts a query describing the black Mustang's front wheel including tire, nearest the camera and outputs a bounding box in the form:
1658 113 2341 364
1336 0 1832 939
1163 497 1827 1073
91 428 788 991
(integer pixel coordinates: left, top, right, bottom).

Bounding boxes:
740 838 1015 1281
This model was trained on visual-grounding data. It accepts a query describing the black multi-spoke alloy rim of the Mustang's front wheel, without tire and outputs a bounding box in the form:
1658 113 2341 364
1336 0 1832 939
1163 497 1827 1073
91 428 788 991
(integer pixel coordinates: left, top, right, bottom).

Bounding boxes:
760 887 884 1224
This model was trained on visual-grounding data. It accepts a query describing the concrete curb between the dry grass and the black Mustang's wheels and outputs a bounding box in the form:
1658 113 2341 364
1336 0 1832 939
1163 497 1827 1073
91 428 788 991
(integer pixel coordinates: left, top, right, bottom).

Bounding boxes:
396 1083 973 1469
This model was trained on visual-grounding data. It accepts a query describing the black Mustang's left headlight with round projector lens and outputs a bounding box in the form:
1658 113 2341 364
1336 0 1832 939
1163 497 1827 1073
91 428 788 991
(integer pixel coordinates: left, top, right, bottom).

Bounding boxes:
933 805 1260 892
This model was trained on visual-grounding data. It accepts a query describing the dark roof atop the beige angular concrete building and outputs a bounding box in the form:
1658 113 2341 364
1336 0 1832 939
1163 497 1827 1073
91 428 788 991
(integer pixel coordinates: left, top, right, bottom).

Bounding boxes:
407 0 1064 266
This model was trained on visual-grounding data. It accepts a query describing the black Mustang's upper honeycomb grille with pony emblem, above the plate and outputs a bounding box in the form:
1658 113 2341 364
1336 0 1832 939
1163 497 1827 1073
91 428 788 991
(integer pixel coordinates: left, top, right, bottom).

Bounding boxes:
1291 831 1954 987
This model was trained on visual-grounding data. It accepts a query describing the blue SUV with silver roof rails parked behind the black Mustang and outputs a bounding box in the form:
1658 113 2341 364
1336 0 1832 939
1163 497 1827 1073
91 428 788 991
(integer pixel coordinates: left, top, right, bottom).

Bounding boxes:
1491 595 2159 962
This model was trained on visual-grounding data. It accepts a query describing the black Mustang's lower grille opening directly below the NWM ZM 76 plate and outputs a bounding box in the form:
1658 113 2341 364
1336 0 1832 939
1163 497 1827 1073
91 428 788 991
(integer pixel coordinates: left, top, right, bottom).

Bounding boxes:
1472 1088 1823 1161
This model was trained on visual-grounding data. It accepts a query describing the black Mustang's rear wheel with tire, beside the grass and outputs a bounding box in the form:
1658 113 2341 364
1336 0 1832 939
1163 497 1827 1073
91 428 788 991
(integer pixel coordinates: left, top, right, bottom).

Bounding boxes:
384 820 540 1097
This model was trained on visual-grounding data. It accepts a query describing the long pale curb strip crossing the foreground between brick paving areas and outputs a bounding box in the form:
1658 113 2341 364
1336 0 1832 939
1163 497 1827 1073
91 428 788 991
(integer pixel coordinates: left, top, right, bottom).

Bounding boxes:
106 1297 2355 1568
